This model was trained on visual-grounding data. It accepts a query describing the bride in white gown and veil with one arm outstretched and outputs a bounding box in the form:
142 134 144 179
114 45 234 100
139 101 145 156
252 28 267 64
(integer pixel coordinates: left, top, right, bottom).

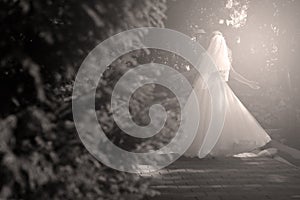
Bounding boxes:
184 31 271 158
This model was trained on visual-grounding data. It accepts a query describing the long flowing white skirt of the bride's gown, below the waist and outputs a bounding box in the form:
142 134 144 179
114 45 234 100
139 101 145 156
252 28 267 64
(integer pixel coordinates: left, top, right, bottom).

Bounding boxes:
184 78 271 158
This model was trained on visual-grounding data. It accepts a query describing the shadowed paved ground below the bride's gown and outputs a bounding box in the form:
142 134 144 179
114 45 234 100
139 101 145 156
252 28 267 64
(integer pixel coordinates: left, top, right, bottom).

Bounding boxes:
141 157 300 200
